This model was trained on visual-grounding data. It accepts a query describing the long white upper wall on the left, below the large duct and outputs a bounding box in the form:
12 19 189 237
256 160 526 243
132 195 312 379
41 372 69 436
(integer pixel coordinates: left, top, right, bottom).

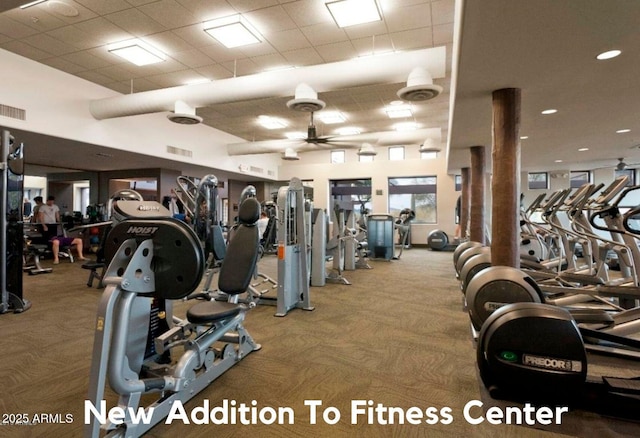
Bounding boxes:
0 46 280 178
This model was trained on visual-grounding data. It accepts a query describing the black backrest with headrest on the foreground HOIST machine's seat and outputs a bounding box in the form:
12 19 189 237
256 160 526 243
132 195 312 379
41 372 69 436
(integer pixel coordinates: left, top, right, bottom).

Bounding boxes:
218 198 260 294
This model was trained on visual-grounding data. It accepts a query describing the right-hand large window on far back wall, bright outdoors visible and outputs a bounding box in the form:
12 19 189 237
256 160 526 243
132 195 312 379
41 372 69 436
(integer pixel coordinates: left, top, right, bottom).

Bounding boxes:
389 176 437 224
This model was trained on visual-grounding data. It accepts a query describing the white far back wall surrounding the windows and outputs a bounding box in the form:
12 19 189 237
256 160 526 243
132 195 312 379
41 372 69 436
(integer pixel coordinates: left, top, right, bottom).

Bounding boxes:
278 146 460 244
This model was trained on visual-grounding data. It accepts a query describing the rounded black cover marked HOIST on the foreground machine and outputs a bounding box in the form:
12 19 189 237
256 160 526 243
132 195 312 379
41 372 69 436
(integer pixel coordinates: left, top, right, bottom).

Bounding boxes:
105 217 205 300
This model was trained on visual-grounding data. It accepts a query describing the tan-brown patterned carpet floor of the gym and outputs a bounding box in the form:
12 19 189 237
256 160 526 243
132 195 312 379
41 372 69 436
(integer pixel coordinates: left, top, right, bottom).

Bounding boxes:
0 248 640 438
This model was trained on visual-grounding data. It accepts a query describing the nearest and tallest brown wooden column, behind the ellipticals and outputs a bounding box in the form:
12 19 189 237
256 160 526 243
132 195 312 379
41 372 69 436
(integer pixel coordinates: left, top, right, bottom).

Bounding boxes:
491 88 520 268
